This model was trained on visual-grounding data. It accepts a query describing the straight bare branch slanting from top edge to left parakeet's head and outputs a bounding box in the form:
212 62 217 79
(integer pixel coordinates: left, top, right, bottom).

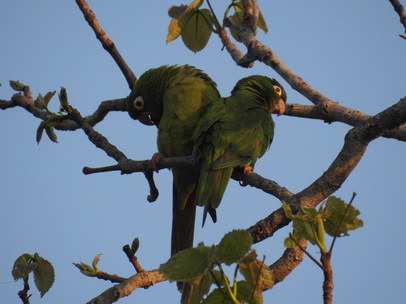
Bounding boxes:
76 0 137 90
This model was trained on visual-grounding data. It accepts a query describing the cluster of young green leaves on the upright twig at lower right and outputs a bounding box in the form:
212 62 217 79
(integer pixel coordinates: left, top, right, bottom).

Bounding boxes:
282 196 363 253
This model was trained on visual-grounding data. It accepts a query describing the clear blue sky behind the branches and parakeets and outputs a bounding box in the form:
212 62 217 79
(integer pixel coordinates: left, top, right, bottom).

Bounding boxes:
0 0 406 304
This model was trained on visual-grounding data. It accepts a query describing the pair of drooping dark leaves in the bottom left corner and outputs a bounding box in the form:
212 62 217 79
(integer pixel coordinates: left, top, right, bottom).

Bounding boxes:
11 253 55 297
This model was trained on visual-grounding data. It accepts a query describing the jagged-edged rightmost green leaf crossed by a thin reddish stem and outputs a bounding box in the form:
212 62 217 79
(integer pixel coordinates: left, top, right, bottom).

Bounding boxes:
321 196 364 237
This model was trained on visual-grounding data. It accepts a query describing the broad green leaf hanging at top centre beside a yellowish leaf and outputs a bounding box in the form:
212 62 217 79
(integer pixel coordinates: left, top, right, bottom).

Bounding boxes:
179 9 213 53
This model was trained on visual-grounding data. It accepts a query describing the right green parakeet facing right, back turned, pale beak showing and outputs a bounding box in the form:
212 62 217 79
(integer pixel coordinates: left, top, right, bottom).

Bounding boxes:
192 75 286 224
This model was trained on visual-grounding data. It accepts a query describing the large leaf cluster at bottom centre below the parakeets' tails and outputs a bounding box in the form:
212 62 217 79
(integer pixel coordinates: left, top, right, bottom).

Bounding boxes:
159 230 273 304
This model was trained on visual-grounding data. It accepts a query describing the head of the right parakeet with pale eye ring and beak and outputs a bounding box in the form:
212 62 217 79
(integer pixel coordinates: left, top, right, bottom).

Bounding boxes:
231 75 287 115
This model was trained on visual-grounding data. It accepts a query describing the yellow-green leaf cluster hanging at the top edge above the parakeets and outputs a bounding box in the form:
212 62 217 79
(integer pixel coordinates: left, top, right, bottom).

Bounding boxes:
166 0 268 53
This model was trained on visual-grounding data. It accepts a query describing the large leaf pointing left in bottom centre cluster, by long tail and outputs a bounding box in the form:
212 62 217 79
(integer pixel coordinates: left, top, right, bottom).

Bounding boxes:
159 243 215 282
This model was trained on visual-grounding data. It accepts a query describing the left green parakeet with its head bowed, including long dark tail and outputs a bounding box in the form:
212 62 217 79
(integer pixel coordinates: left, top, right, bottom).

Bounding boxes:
127 65 220 255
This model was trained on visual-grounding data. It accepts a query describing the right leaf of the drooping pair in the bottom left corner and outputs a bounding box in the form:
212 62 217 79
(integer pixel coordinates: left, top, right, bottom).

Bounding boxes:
33 253 55 298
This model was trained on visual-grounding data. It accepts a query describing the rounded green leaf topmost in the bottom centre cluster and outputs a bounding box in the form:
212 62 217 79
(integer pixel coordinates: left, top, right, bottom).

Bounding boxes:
216 230 252 265
